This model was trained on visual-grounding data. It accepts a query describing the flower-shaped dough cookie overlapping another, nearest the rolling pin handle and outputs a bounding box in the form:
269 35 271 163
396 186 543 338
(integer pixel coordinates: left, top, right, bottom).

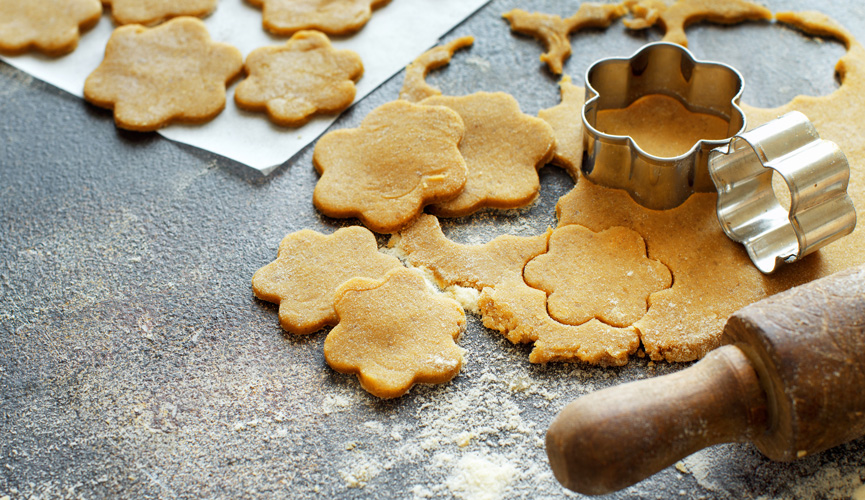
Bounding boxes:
324 269 466 398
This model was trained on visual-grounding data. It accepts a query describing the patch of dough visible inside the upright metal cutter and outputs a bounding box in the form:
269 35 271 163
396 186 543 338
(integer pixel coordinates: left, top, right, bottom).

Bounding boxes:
596 94 730 158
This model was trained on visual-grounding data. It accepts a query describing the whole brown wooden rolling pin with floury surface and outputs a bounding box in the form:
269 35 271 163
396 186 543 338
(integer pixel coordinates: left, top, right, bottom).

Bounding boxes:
547 266 865 495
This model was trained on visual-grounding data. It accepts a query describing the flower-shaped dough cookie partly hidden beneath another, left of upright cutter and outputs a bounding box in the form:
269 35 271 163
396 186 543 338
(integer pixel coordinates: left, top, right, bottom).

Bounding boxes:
421 92 555 217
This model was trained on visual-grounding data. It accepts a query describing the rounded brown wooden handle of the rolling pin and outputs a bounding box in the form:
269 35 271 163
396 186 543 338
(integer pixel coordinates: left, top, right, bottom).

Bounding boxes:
547 345 768 495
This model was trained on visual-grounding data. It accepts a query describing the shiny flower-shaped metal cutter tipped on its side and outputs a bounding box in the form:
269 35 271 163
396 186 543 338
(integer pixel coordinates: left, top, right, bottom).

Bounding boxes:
709 111 856 273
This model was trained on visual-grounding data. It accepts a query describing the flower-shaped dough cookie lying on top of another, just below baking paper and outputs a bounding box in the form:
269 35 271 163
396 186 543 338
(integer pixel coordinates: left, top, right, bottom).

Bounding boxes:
312 101 466 233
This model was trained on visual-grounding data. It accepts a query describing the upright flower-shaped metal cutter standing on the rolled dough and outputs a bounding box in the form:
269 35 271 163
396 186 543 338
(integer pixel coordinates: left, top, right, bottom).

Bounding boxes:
582 42 745 210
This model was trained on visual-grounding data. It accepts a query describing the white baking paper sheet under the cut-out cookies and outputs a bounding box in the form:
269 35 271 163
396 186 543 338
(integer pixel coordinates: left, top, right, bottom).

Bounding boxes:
2 0 489 174
